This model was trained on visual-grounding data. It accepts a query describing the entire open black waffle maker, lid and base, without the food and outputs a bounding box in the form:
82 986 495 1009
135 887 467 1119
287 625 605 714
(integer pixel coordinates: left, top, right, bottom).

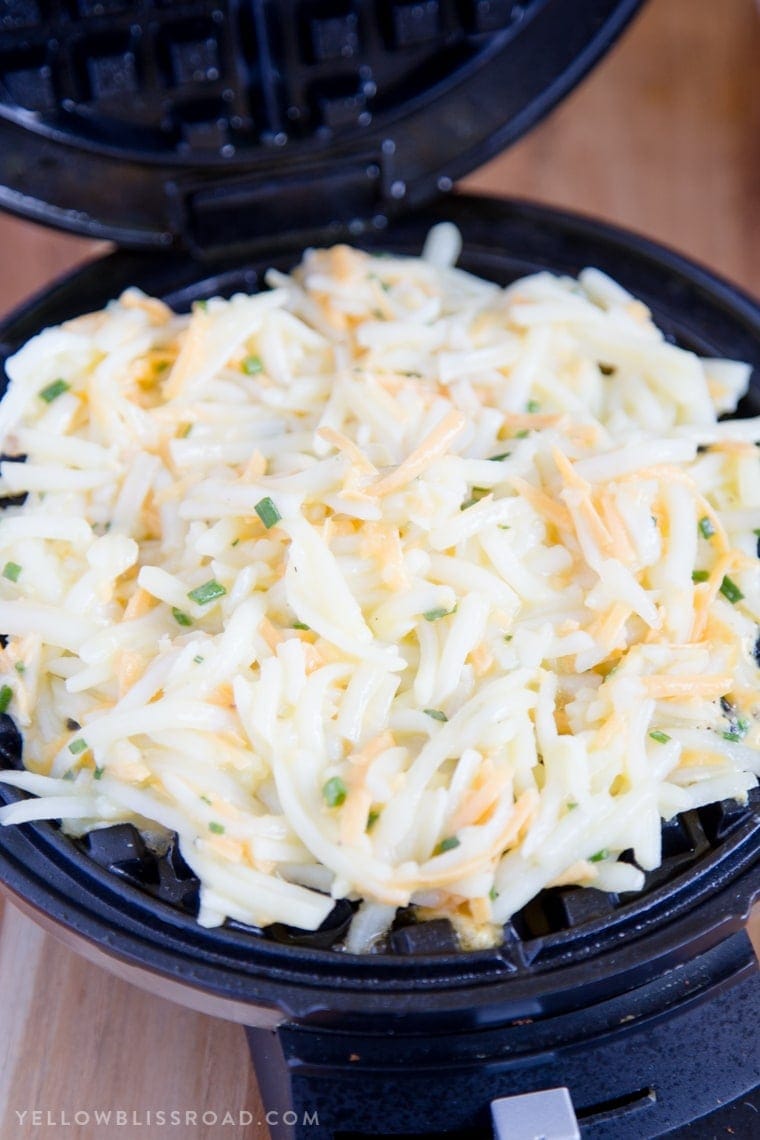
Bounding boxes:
0 0 760 1140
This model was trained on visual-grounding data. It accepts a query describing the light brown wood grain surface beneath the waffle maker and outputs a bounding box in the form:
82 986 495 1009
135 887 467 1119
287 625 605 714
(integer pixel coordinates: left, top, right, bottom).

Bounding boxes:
0 0 760 1140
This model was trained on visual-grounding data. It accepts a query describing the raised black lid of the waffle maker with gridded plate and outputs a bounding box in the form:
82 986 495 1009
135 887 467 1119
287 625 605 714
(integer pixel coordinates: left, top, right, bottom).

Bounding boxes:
0 0 640 257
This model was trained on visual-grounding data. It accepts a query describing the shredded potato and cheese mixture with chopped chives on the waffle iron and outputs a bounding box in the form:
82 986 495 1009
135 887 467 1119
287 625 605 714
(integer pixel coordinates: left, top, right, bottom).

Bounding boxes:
0 226 760 951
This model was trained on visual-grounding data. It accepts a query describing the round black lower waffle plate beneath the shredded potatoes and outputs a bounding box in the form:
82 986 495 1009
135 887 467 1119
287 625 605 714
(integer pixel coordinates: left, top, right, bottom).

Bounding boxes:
0 197 760 1018
